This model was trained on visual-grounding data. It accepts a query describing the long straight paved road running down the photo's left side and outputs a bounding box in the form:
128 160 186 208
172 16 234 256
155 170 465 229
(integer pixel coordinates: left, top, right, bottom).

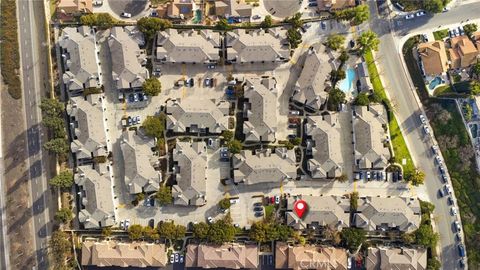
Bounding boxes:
16 0 50 269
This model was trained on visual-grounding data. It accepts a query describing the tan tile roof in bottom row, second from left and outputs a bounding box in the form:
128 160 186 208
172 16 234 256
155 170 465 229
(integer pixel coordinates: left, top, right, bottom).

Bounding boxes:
185 243 259 269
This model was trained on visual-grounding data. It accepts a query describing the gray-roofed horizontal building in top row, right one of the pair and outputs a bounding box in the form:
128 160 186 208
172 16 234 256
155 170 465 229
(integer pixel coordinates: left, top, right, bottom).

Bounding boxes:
225 27 290 63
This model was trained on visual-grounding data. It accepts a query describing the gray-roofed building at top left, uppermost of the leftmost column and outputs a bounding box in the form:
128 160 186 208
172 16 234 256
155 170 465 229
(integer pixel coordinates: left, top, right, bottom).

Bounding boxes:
58 26 100 90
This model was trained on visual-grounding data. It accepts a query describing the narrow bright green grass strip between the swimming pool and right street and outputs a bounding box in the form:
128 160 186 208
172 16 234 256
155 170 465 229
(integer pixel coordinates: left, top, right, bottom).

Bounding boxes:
365 52 415 177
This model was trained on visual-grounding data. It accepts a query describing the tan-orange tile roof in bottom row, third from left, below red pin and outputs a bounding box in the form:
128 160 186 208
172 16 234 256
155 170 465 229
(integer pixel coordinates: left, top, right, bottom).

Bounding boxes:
275 242 348 270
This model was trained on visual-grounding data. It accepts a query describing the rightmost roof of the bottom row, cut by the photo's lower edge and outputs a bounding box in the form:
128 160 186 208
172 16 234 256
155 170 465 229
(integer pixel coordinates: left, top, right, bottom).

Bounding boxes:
365 247 427 270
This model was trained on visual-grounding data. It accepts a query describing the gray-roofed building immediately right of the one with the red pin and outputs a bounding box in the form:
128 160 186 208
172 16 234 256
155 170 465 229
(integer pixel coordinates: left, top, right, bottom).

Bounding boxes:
354 197 421 232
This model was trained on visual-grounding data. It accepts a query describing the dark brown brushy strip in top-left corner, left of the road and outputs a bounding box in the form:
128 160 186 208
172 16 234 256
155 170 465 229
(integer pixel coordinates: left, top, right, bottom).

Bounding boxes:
0 1 22 99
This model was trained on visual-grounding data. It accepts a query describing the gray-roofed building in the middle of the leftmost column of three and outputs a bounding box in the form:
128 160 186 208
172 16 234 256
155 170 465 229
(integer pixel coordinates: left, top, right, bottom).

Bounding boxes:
67 94 107 159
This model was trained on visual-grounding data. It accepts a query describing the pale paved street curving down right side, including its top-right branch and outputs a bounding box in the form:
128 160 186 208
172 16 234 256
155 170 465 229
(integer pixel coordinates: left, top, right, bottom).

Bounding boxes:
370 1 480 269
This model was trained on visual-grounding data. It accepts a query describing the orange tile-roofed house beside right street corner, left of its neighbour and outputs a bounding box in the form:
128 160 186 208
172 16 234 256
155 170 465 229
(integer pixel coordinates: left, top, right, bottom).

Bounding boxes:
417 40 448 76
